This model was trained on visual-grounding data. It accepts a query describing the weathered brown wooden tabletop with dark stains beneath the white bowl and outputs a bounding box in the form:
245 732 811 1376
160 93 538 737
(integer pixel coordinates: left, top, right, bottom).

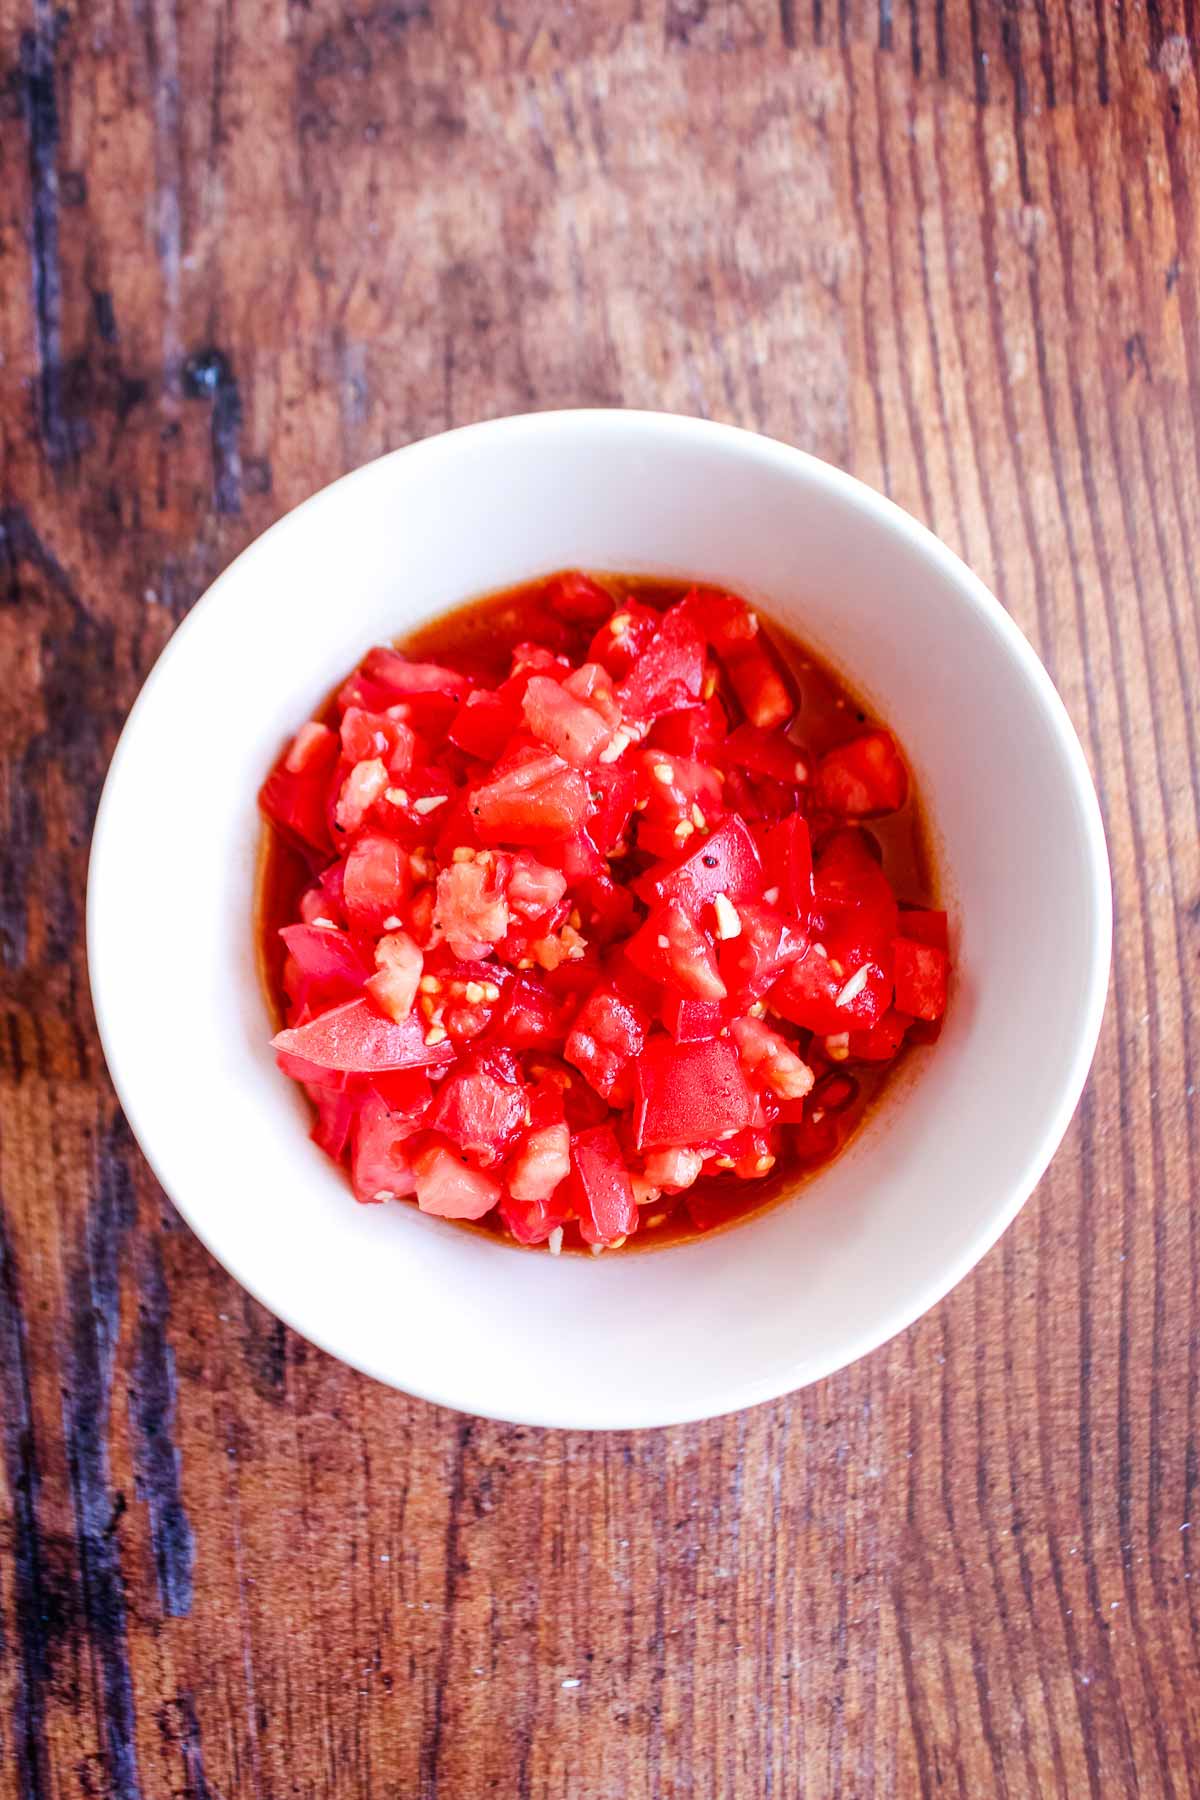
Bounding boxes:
0 0 1200 1800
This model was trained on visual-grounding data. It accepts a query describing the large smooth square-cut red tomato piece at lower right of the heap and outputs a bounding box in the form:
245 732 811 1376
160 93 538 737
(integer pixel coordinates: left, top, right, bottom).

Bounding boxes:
633 1033 759 1150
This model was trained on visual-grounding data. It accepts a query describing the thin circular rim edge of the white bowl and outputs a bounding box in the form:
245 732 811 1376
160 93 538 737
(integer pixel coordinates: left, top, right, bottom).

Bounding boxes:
86 407 1112 1429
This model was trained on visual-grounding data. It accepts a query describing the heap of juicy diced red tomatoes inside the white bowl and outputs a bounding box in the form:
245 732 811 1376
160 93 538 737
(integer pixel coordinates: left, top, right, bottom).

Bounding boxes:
261 572 950 1251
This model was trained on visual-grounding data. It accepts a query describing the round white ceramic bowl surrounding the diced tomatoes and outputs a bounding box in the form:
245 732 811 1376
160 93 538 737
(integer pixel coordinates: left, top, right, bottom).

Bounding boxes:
88 412 1110 1427
